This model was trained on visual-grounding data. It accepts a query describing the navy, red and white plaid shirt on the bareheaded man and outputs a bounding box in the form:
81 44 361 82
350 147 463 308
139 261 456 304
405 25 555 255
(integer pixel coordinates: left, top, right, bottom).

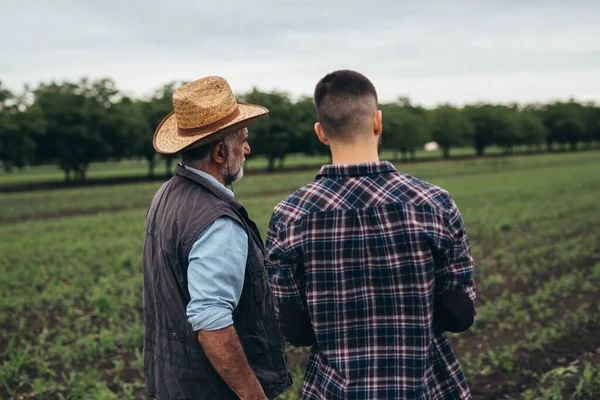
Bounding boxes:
267 162 475 400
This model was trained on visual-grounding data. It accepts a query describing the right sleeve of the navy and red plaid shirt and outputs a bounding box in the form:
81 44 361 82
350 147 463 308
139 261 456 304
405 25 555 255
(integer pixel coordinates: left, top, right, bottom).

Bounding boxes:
436 198 476 302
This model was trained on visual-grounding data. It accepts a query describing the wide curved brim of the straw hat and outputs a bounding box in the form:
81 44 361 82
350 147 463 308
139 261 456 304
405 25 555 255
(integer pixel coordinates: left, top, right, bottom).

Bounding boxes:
152 101 269 154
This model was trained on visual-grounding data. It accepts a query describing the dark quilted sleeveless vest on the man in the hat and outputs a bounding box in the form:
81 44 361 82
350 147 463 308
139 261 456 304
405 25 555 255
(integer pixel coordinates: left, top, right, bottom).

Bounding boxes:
143 165 291 400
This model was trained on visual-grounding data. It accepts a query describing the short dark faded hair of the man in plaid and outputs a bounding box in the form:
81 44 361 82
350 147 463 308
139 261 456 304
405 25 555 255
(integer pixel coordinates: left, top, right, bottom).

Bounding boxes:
315 69 377 138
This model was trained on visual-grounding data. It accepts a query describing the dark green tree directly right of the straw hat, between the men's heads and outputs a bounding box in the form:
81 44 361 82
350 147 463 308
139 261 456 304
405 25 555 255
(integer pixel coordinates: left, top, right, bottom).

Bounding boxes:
242 89 295 172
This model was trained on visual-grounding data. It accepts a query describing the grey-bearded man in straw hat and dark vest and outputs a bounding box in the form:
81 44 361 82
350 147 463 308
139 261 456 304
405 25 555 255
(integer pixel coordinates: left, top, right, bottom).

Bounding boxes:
143 77 291 400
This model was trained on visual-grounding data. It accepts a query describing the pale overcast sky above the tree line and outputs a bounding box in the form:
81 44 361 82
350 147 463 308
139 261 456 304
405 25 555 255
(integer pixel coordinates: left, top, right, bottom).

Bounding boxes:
0 0 600 106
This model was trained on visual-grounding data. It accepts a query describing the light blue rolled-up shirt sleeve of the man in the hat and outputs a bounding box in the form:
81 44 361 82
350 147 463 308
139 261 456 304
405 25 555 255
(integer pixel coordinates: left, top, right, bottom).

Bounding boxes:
187 217 248 331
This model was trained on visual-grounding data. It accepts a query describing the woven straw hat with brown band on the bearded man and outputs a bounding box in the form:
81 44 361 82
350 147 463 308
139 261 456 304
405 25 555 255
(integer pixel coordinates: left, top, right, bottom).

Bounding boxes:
152 76 269 154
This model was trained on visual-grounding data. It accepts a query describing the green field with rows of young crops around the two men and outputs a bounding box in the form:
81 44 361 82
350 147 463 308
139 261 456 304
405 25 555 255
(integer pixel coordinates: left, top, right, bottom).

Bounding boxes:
0 151 600 399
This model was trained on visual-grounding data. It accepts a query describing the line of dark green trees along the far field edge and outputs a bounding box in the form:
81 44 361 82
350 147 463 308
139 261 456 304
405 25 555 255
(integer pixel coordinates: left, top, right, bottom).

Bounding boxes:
0 78 600 181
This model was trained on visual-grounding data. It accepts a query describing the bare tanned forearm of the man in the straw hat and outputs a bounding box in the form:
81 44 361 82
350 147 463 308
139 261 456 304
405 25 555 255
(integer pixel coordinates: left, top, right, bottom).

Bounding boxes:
198 325 267 400
